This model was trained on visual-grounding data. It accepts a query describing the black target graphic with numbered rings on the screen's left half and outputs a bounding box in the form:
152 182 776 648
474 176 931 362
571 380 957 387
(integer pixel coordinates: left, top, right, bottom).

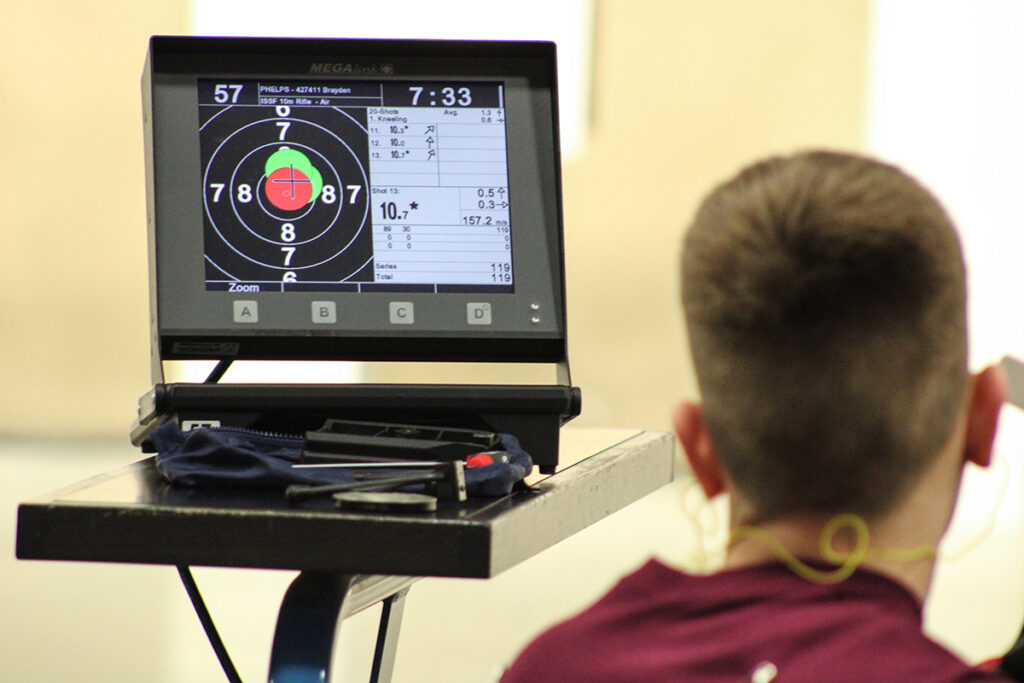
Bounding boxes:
200 105 373 289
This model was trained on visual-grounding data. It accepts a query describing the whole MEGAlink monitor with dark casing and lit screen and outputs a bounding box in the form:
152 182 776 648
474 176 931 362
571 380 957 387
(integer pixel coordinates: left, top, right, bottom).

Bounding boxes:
143 37 565 361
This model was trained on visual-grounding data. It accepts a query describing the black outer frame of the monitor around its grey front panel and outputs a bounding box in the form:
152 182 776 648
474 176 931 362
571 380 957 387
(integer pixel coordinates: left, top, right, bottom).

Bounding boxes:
142 36 566 362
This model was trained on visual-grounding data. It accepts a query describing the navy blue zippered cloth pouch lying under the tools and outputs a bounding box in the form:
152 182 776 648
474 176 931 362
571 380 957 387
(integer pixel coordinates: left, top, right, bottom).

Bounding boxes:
151 420 534 498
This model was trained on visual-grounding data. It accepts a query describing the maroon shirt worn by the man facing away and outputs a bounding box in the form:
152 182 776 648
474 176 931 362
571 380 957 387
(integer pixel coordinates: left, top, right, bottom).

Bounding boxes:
501 560 1009 683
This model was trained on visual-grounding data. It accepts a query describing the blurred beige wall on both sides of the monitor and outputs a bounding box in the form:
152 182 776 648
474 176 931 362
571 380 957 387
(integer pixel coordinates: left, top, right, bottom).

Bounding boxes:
0 0 868 435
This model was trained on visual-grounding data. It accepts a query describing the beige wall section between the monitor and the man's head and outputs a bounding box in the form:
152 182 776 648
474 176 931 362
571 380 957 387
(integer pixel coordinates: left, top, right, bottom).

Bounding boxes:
564 0 869 427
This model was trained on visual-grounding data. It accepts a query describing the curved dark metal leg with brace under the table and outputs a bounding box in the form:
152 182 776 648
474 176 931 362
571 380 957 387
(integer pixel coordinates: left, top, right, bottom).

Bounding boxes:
268 571 417 683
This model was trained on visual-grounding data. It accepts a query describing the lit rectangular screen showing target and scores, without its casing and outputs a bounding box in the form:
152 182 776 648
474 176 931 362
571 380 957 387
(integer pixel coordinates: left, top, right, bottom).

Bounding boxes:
197 79 515 293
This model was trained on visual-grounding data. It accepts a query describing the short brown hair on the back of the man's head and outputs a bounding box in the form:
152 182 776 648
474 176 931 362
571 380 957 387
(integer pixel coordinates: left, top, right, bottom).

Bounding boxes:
683 152 967 521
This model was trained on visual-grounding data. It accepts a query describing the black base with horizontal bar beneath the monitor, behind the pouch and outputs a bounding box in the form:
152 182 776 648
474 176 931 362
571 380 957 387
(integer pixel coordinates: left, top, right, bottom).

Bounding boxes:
131 360 582 474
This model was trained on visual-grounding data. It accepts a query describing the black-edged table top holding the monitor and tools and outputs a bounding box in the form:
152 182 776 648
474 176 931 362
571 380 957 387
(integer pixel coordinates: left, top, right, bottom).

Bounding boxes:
16 428 674 578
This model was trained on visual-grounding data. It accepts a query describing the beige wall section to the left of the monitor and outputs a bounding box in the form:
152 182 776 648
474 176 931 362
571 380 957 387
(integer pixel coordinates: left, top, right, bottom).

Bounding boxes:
0 0 187 435
